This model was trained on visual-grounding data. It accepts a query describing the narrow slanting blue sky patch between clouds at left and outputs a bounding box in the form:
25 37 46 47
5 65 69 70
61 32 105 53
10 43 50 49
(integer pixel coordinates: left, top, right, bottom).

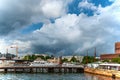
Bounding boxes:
20 23 43 34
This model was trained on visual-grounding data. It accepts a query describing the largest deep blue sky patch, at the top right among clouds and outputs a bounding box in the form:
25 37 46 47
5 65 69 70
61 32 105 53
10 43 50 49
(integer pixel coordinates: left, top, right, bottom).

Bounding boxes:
68 0 113 16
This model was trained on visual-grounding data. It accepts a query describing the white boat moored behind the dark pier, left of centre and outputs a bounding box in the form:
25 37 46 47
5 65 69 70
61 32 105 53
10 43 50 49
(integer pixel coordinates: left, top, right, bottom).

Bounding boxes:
30 61 58 66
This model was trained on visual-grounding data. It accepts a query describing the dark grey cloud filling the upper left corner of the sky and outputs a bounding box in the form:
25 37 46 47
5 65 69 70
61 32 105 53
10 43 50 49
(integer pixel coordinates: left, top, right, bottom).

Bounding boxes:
0 0 40 35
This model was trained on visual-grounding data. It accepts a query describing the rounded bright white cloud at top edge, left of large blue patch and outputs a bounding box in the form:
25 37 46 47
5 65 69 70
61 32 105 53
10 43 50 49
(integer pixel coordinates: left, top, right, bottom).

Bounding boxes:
42 0 65 18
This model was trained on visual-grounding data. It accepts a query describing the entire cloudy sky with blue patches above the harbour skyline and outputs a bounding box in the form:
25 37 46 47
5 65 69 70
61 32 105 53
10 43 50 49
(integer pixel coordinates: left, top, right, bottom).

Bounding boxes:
0 0 120 56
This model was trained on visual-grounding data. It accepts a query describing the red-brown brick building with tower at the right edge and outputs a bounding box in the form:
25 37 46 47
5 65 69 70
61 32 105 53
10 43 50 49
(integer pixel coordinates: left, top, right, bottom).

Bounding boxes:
100 42 120 60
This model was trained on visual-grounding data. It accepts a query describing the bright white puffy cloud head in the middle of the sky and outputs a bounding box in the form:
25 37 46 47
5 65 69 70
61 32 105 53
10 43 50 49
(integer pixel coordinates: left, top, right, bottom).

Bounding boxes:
34 14 82 43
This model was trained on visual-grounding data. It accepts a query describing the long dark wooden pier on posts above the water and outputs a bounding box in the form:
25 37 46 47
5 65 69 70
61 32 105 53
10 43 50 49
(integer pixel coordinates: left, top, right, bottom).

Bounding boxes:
0 66 84 73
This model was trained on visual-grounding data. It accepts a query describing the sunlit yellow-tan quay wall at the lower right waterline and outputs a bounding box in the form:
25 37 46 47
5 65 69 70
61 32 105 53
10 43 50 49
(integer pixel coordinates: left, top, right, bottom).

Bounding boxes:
84 68 120 78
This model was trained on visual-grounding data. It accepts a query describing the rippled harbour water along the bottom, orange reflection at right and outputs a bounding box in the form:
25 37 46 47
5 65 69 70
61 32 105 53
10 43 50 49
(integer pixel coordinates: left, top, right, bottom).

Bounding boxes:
0 73 120 80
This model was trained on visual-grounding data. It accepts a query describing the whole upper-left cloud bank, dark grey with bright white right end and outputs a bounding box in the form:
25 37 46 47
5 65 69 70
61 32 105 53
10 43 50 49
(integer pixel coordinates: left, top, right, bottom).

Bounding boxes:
0 0 71 35
